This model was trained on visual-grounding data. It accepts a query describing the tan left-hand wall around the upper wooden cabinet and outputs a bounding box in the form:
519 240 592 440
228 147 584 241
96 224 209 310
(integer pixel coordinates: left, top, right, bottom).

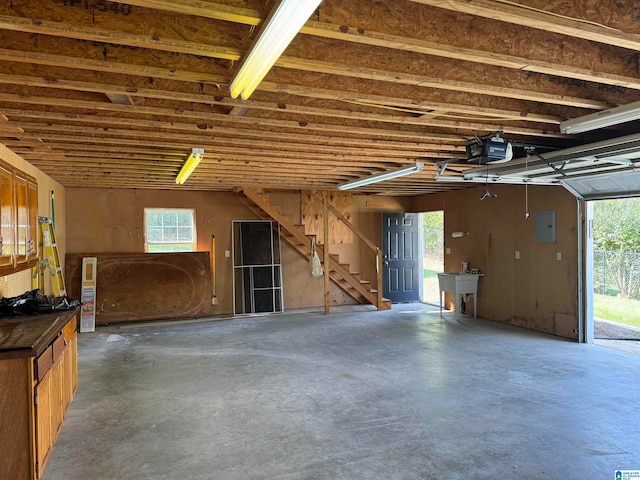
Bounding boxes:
0 144 67 297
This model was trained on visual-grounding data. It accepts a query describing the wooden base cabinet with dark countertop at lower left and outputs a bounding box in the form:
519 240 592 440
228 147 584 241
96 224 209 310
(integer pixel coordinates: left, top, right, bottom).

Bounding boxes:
0 310 79 480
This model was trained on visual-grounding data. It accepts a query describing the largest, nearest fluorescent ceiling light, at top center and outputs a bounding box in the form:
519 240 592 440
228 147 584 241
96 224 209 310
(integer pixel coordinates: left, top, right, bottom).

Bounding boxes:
229 0 322 100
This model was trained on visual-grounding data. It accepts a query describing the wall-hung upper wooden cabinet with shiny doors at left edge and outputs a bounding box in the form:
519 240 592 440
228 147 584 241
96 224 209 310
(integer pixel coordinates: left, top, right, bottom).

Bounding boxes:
0 162 38 275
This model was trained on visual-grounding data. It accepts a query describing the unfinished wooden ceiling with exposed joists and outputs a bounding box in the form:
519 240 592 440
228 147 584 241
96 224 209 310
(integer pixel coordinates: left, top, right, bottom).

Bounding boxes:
0 0 640 195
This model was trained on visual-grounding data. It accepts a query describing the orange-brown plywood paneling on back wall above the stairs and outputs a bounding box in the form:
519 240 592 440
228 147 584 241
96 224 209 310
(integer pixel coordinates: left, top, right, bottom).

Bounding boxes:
300 190 353 244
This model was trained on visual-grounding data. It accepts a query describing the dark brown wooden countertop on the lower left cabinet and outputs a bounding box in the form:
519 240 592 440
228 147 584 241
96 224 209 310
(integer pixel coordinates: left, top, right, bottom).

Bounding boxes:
0 308 78 359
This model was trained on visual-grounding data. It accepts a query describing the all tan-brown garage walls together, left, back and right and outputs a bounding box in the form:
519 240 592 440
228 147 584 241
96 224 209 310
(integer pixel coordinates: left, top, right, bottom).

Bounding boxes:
0 144 578 338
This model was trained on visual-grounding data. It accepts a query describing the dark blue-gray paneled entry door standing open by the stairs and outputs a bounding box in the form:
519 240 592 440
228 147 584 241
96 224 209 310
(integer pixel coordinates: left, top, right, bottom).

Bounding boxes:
382 213 420 303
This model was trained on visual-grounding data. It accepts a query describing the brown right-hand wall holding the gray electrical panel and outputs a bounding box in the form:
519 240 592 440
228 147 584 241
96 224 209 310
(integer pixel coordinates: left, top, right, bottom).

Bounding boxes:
410 185 578 339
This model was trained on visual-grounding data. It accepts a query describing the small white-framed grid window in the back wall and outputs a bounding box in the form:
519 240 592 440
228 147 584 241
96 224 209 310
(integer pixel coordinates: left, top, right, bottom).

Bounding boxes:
144 208 197 253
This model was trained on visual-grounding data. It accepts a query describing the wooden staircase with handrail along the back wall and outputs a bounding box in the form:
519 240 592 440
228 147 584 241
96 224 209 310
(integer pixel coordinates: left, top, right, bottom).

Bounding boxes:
236 188 391 310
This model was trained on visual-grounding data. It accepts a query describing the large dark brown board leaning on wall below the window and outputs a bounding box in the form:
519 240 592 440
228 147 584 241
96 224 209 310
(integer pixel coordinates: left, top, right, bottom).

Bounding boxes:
66 252 211 325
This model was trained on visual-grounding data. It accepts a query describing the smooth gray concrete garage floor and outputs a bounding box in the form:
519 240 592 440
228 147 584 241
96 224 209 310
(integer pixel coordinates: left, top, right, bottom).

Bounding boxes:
43 304 640 480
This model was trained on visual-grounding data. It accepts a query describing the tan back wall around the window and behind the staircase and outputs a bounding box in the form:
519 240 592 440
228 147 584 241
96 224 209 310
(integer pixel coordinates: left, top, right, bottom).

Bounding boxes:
66 188 404 315
